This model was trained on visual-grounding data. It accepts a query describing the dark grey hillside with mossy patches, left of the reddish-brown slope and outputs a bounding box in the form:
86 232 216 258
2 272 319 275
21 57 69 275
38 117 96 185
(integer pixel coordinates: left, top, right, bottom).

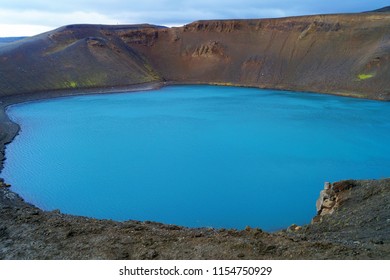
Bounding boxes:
0 25 161 96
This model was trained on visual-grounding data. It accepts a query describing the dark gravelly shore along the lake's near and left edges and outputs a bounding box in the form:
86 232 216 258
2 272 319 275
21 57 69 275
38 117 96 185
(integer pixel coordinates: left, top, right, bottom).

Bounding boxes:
0 83 390 259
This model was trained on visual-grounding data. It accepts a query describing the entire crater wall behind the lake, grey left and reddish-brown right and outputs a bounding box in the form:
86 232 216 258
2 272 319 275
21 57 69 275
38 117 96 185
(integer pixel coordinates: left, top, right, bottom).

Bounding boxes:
0 13 390 100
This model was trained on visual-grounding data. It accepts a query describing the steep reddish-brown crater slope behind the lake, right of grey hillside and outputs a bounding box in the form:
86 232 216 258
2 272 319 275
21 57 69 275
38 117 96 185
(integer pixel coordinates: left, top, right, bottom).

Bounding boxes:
132 14 390 99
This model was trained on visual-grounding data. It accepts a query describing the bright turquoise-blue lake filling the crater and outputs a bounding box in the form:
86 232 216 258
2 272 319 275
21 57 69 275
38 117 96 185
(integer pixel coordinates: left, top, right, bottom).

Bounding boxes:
1 86 390 230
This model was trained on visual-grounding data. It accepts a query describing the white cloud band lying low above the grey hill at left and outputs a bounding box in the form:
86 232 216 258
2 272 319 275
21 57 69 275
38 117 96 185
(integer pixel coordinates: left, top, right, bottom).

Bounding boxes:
0 8 229 37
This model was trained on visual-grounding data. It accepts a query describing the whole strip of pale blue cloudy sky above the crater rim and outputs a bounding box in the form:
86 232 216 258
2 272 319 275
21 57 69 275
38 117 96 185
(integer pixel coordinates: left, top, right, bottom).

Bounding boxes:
0 0 389 37
